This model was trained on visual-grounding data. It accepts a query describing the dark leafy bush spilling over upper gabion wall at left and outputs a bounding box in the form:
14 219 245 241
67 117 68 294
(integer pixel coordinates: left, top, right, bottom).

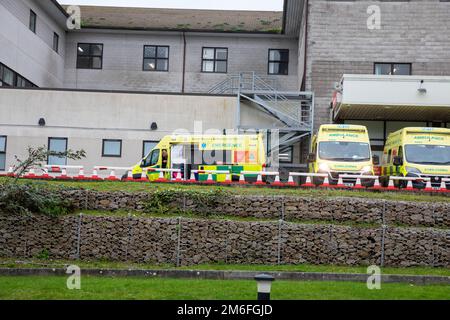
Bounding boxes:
0 184 75 216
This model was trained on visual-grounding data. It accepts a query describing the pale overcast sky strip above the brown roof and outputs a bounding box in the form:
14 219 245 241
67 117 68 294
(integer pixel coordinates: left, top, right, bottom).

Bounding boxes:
58 0 283 11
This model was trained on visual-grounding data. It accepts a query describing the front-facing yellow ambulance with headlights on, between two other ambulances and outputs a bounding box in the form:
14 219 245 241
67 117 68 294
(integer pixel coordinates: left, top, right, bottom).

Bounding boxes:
308 124 377 186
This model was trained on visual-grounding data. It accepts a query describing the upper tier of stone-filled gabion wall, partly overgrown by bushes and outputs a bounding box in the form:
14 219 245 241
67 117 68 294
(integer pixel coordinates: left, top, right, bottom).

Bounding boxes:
54 190 450 228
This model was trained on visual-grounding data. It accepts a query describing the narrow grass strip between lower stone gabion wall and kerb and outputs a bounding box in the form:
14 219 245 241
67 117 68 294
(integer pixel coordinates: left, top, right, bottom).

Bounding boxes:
0 258 450 276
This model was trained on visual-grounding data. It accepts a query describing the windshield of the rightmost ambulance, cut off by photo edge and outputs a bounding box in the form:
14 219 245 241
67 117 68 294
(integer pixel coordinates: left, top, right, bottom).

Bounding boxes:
405 144 450 165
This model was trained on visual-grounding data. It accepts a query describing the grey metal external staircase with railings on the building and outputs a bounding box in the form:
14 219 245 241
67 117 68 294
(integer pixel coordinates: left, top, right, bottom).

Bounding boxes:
208 72 314 169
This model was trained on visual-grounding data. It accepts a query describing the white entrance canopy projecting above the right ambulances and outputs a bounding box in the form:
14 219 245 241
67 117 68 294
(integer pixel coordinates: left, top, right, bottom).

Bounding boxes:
332 74 450 122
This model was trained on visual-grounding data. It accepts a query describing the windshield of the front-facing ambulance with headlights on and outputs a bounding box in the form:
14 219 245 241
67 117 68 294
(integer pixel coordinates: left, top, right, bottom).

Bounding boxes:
319 141 370 161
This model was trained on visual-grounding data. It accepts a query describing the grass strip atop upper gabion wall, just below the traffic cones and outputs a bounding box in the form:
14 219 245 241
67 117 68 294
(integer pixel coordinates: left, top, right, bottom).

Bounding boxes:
0 178 450 202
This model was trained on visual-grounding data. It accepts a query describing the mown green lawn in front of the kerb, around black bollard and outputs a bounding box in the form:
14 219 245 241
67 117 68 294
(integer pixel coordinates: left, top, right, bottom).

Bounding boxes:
0 276 450 300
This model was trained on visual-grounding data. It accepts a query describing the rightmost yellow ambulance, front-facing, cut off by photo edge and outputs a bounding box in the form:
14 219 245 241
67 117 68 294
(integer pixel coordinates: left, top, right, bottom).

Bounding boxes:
382 127 450 188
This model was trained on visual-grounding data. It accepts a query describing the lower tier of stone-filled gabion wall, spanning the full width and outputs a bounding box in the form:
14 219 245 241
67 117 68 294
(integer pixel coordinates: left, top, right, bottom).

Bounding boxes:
0 215 450 267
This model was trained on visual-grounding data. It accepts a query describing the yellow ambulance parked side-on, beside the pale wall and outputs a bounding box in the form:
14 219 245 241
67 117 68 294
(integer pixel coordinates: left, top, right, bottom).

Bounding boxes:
132 134 266 182
